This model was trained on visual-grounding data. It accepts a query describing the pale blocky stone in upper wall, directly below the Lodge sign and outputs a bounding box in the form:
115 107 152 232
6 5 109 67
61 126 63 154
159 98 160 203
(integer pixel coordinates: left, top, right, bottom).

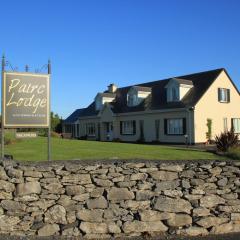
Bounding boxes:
16 182 41 196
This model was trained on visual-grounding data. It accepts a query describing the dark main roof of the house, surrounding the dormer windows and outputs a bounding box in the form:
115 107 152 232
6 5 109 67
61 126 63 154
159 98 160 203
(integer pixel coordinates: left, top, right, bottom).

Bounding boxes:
66 68 235 117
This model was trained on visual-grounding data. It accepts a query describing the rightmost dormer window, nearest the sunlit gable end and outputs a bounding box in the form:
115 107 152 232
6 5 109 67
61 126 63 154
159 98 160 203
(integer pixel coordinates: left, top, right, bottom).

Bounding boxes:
165 78 193 102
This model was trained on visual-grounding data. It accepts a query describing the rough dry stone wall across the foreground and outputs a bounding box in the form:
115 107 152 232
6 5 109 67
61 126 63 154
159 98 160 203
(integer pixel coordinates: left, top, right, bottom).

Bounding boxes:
0 161 240 239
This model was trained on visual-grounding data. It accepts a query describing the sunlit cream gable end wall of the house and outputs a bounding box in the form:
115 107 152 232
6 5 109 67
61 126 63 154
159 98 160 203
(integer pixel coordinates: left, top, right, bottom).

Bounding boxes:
194 71 240 142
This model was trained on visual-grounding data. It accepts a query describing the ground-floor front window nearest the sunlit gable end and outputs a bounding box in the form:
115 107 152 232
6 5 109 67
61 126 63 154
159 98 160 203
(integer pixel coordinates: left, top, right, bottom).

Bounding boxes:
165 118 186 135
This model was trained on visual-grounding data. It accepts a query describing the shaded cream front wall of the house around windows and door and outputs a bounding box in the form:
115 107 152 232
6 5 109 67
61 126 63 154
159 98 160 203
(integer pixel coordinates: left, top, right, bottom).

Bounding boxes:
72 107 194 143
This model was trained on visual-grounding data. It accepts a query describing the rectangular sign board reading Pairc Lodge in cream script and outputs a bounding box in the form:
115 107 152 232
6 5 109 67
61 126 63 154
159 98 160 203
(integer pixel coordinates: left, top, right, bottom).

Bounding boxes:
3 72 50 128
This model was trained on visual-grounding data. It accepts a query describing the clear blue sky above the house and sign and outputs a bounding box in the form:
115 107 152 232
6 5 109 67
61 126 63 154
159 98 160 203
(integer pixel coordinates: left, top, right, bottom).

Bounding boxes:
0 0 240 118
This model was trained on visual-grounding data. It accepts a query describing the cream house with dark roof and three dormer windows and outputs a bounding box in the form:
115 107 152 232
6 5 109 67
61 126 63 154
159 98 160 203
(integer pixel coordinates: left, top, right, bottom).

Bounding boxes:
63 69 240 144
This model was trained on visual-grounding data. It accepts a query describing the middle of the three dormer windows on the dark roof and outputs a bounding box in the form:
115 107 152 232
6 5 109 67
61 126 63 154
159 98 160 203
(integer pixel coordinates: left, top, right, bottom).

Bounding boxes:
127 86 151 107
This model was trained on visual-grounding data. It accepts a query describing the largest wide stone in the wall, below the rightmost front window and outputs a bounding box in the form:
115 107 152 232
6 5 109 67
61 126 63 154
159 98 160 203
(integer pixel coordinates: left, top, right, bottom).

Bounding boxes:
154 197 192 214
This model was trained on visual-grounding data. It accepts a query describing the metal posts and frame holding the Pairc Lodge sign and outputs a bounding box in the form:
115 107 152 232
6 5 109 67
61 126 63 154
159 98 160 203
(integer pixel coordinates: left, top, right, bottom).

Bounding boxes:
1 55 51 161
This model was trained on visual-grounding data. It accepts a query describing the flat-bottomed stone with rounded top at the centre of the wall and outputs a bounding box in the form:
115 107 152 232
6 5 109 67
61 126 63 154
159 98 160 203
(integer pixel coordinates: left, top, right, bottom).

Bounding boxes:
107 187 135 201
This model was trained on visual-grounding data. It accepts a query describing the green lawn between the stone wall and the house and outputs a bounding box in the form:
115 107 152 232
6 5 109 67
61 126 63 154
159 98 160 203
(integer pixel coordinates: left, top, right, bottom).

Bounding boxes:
5 137 225 161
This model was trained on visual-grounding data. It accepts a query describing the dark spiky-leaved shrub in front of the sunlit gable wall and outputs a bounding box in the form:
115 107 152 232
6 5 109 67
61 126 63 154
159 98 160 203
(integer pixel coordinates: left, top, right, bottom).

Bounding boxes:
215 129 238 152
